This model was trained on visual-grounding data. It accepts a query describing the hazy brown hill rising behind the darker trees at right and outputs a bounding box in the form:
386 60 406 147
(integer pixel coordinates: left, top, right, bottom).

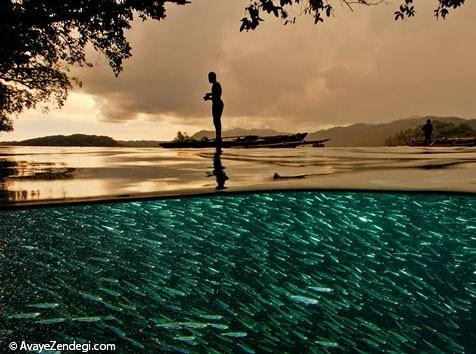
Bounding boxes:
306 116 476 146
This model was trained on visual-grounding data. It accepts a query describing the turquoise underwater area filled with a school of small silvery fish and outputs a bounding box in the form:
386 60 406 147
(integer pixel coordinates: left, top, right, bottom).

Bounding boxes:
0 192 476 353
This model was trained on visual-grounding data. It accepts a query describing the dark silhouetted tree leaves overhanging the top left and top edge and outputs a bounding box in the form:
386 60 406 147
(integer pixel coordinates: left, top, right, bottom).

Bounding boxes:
0 0 464 131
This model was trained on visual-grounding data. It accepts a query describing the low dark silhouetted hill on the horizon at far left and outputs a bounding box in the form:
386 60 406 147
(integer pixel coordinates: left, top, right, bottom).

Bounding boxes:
0 134 119 147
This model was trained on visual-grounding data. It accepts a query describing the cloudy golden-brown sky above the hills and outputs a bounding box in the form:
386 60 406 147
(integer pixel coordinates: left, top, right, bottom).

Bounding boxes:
0 0 476 140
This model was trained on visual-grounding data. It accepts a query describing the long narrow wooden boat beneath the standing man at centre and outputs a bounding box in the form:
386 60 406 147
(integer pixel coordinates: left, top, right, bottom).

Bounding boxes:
159 133 329 148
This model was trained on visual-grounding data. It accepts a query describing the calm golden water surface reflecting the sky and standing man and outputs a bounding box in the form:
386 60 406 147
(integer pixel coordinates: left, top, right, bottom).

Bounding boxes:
0 147 476 206
